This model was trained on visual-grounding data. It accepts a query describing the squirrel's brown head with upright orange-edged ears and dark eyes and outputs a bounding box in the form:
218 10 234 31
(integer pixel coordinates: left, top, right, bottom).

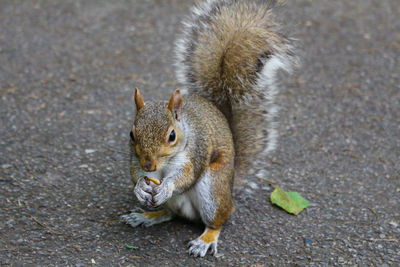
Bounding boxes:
130 88 183 172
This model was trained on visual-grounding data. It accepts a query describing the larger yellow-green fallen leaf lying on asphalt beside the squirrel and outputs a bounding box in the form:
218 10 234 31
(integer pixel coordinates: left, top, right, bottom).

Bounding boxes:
271 186 309 215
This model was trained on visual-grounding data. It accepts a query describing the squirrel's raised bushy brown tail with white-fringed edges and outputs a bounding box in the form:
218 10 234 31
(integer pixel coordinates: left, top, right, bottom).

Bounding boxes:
176 0 296 178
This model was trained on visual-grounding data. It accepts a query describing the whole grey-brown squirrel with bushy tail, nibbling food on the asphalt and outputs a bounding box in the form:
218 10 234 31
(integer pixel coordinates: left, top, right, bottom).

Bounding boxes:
122 0 296 257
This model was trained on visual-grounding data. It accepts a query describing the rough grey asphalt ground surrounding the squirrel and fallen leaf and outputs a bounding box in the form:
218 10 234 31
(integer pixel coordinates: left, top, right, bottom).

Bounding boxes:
0 0 400 266
